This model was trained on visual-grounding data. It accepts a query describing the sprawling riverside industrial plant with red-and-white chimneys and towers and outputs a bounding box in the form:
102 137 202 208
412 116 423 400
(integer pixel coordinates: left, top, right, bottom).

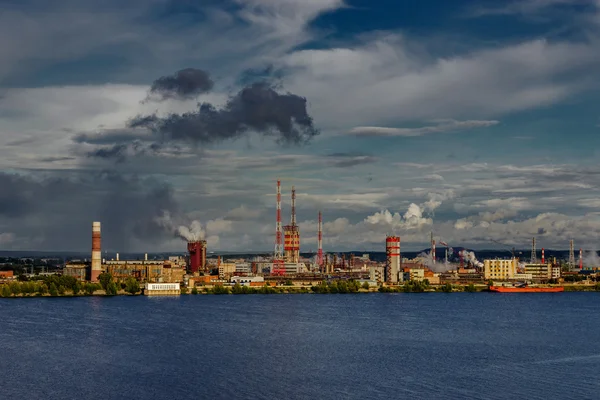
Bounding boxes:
2 180 599 294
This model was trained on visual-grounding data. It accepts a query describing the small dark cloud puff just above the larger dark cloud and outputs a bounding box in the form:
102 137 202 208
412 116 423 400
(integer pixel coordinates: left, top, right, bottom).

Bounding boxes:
146 68 214 101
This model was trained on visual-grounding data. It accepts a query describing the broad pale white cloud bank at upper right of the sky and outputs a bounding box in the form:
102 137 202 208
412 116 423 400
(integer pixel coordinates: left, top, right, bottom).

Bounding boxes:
279 34 600 128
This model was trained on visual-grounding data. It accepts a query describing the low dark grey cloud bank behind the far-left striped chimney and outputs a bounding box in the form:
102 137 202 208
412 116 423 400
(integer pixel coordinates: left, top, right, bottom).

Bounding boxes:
0 172 178 251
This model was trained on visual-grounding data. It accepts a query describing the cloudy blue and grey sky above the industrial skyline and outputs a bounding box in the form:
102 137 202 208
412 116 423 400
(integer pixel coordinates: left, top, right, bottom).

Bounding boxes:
0 0 600 252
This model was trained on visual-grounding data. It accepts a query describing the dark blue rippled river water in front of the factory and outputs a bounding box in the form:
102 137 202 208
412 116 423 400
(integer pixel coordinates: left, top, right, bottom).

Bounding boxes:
0 293 600 400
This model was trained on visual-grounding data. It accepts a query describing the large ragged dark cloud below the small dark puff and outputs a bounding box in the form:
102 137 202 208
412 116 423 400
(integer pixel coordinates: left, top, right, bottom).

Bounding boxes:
129 83 319 144
